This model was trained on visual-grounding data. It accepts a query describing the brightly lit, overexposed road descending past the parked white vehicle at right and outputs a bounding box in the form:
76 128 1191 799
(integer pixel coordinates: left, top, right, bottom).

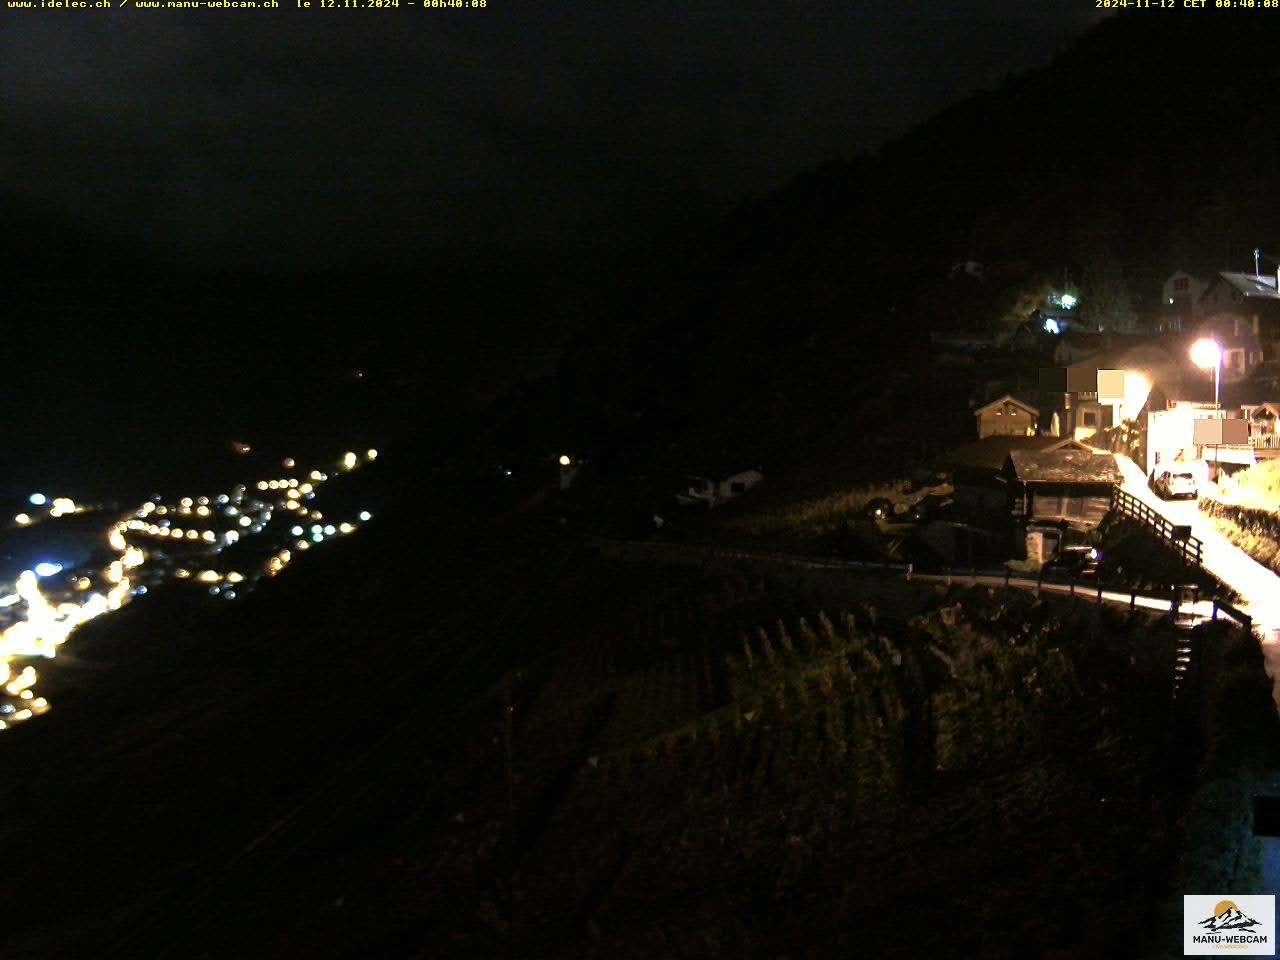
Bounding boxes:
1116 453 1280 708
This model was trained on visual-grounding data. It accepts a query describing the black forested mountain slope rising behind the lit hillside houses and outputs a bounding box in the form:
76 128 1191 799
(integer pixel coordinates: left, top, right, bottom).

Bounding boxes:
559 10 1280 476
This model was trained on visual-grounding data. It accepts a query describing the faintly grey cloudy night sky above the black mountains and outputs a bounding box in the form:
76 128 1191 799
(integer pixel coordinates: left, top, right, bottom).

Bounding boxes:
0 0 1096 281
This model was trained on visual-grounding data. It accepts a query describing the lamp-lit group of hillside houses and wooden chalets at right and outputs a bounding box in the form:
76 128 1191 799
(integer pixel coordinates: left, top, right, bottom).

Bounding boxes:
824 264 1280 576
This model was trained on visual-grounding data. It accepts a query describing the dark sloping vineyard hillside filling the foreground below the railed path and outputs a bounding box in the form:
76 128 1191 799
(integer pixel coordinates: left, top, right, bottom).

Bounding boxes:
0 476 1259 959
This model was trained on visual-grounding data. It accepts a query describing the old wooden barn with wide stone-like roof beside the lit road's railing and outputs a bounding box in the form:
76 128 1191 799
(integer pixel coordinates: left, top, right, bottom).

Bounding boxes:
1002 449 1124 526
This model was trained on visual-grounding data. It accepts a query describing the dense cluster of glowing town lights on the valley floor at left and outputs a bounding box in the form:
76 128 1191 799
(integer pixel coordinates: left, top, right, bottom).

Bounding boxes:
0 449 378 731
